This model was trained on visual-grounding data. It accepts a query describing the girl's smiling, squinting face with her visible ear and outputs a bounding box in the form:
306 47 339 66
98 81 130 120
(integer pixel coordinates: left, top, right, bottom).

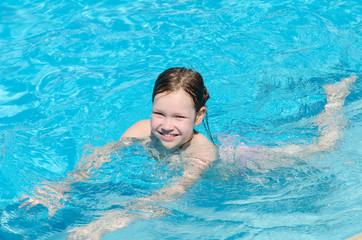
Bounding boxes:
151 89 206 149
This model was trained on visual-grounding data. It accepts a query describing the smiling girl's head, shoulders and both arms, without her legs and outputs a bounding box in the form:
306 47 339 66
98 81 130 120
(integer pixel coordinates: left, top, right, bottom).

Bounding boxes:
20 68 217 239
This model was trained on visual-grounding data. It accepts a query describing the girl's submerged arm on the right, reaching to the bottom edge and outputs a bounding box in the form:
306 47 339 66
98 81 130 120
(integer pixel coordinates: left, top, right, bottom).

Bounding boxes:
67 142 217 239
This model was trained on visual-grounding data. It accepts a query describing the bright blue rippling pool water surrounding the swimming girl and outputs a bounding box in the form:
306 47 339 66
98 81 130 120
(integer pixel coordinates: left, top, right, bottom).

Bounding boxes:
0 0 362 240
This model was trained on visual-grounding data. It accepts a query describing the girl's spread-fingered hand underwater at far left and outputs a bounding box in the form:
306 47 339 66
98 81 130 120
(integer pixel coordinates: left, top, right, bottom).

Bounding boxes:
18 182 70 218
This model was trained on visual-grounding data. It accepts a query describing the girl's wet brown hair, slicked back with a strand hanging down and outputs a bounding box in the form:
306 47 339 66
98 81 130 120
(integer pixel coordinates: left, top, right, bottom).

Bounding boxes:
152 67 214 143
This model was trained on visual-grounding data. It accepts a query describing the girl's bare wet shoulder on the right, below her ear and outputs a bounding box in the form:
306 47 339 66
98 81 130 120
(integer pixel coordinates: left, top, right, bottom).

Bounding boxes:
185 133 218 164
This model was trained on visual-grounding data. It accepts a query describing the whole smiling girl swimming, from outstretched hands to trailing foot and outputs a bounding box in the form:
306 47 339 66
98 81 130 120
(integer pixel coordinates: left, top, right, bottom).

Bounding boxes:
20 68 356 239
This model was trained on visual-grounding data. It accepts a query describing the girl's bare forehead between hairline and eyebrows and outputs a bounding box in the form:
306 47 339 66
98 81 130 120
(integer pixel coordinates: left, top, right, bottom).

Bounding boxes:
153 89 195 111
